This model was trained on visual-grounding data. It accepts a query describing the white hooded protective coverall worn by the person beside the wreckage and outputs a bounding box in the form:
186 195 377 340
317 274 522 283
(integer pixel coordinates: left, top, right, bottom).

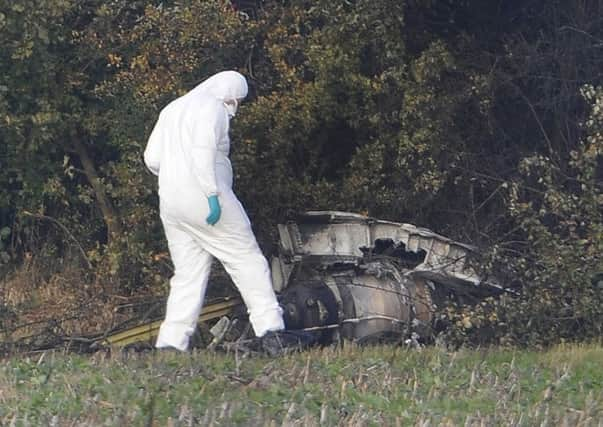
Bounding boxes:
144 71 284 351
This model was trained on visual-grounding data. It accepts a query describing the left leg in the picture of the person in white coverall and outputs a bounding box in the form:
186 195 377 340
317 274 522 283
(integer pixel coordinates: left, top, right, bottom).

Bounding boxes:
155 221 212 351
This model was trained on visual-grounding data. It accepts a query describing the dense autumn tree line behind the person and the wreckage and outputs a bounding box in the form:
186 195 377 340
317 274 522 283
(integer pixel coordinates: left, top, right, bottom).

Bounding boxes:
0 0 603 344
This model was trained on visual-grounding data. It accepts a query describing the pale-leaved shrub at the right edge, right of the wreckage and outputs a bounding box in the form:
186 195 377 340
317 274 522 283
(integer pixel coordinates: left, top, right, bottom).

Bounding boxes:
448 85 603 345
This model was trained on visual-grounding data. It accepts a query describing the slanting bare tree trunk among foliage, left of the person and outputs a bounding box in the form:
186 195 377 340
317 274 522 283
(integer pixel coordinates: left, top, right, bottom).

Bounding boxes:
72 137 121 245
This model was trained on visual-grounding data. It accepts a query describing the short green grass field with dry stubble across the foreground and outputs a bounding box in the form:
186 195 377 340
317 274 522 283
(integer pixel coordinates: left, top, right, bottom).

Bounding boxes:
0 345 603 426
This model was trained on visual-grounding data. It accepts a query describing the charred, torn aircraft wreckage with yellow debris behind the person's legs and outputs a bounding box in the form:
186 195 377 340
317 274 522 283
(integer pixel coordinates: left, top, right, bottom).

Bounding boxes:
98 211 504 354
